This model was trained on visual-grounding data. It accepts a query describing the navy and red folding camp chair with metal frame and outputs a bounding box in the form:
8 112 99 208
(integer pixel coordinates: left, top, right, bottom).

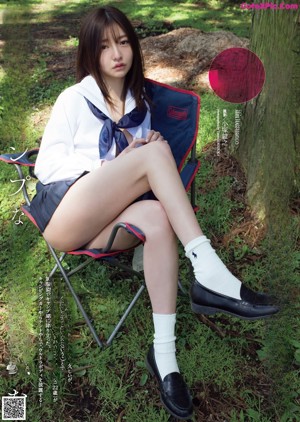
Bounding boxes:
0 79 200 348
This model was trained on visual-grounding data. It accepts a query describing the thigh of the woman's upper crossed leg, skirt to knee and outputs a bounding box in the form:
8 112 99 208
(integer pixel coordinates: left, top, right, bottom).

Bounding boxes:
44 146 164 250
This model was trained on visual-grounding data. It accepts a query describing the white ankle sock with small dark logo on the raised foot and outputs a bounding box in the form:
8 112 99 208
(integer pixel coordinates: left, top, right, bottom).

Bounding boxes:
184 236 242 299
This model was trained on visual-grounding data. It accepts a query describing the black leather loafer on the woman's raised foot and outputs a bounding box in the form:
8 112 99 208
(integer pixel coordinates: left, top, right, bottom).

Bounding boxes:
190 281 279 320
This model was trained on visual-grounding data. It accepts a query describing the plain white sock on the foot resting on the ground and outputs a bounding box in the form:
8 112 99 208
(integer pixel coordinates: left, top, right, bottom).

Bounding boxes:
153 314 179 380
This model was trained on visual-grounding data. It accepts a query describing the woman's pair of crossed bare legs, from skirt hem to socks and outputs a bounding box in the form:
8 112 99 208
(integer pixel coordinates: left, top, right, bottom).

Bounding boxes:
44 142 193 314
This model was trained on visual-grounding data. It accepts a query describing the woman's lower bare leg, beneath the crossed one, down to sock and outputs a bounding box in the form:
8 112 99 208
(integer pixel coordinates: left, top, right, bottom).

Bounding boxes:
86 201 178 314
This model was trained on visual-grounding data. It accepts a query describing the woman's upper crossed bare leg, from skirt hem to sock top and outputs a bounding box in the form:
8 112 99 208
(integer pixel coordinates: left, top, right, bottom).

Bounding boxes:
44 142 202 250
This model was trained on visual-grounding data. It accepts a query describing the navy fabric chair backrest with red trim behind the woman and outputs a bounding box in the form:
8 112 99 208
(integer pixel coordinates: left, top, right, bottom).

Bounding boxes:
145 79 200 170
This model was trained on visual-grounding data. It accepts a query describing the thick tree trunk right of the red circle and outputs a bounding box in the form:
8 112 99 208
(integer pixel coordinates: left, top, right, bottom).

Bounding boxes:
236 2 300 222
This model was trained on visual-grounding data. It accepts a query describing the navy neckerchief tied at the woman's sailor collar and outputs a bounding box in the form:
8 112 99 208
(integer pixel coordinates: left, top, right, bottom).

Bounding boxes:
84 97 147 158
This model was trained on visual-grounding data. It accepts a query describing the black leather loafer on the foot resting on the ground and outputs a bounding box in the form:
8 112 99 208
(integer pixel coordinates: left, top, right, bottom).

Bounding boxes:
146 345 193 419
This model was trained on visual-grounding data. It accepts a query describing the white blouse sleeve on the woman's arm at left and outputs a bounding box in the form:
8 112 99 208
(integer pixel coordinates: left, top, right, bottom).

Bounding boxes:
35 90 101 184
